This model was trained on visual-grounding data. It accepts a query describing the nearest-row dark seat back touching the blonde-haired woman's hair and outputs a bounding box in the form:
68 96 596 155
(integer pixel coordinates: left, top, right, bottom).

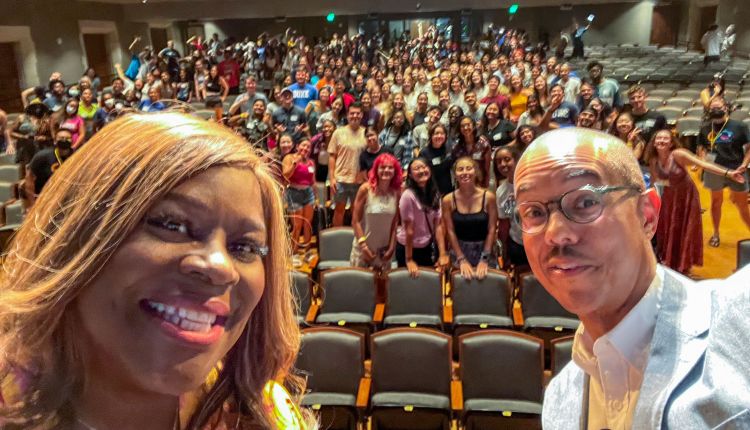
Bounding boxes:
296 327 365 396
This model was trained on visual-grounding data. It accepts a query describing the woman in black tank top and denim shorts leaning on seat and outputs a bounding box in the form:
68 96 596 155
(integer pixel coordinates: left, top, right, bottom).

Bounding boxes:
442 157 497 279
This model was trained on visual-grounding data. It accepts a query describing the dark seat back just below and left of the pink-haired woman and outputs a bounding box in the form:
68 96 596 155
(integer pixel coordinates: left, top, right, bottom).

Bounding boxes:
320 268 376 315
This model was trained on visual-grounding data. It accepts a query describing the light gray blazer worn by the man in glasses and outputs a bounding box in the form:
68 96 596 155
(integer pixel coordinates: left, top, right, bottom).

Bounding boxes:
542 266 750 430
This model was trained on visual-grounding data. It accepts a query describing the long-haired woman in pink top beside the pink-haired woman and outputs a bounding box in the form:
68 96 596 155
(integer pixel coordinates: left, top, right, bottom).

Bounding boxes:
396 158 449 277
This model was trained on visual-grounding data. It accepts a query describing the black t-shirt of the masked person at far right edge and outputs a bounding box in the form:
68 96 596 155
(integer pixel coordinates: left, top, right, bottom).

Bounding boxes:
698 119 750 169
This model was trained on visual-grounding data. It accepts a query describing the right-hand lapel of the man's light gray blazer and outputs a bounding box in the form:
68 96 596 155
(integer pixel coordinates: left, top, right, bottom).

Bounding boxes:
632 268 711 429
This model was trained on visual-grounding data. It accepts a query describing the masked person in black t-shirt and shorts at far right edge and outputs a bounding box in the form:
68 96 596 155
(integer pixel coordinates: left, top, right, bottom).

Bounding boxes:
698 98 750 248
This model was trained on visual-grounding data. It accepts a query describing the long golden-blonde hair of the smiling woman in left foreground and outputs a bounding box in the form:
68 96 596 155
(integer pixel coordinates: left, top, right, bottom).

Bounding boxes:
0 113 302 429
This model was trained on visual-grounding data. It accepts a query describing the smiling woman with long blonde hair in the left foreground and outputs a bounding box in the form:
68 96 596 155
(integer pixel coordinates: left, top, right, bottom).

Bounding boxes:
0 113 304 429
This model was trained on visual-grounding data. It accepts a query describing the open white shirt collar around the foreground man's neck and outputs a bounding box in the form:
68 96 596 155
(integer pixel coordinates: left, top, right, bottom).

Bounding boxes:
573 265 664 376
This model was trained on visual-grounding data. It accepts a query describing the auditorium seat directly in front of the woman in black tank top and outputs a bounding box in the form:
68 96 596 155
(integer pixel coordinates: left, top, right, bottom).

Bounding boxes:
451 270 513 336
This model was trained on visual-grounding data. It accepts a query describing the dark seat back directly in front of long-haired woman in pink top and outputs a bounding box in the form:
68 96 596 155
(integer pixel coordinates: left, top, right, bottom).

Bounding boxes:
386 269 443 319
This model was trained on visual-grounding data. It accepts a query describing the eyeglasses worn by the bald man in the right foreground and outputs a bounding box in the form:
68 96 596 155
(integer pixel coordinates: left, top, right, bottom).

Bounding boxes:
514 185 643 234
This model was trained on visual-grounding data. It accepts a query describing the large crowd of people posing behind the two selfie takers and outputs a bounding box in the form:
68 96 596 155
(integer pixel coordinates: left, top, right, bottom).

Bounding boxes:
1 22 750 277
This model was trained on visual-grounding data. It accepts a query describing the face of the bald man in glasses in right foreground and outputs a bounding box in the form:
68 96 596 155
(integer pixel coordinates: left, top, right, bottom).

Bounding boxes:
515 137 653 316
